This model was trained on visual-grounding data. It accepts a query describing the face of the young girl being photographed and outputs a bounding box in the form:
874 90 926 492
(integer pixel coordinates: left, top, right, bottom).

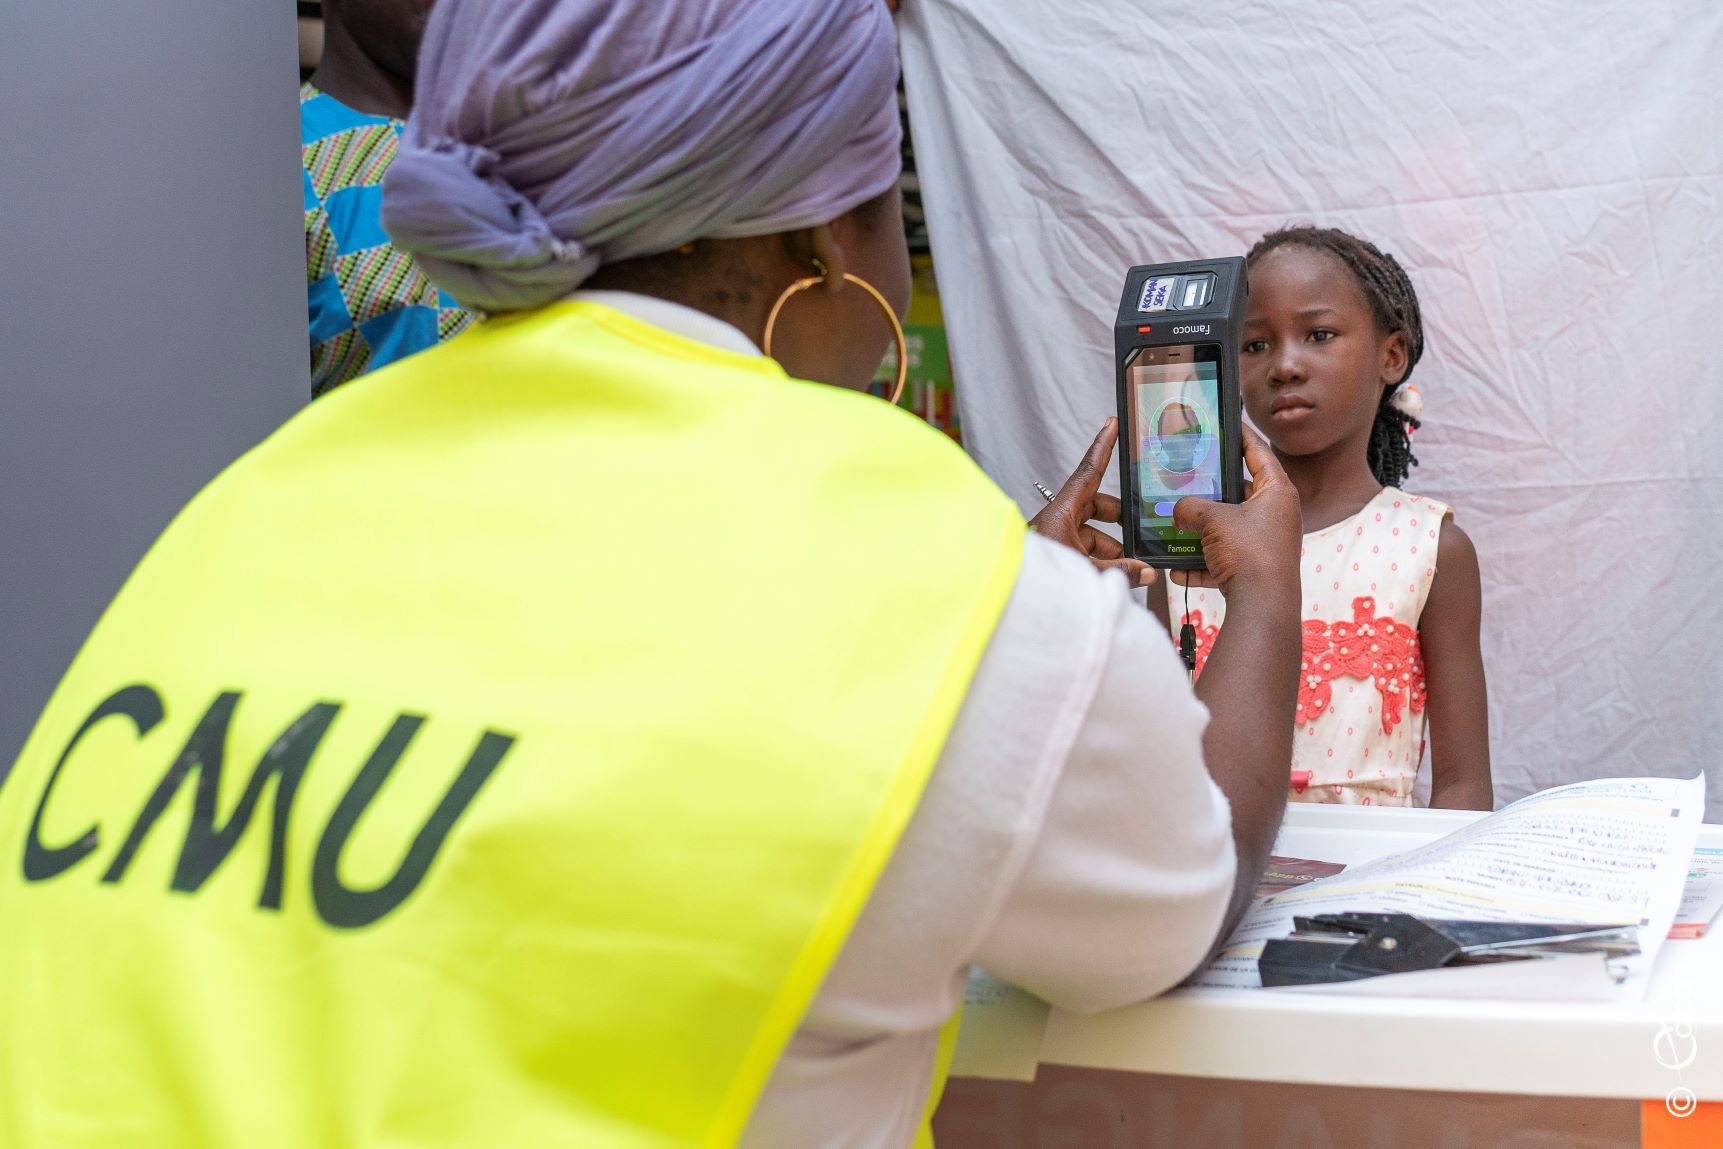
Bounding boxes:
1239 245 1406 463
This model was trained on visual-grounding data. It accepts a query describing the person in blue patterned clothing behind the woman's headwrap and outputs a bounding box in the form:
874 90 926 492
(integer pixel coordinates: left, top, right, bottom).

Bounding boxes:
300 0 472 396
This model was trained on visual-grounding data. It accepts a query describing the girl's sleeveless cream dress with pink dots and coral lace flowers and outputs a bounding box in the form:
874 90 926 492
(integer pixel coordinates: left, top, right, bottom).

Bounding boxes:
1166 488 1451 806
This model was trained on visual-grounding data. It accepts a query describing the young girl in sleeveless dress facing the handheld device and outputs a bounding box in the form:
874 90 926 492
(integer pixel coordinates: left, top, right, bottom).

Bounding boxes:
1168 227 1492 810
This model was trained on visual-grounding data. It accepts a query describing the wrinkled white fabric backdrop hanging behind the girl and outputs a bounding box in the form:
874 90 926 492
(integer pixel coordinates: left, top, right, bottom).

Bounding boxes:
901 0 1723 820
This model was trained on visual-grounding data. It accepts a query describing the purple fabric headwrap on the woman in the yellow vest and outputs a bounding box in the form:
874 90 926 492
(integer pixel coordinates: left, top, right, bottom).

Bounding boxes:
383 0 901 312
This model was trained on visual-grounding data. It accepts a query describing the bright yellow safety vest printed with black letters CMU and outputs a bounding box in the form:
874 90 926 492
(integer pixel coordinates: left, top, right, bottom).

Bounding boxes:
0 303 1023 1149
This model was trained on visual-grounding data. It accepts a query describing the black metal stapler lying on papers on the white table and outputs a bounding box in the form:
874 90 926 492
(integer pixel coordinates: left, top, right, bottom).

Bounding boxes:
1258 913 1639 985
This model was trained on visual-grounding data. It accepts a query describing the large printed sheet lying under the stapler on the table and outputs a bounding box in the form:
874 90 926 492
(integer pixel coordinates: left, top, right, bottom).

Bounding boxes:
1191 775 1706 997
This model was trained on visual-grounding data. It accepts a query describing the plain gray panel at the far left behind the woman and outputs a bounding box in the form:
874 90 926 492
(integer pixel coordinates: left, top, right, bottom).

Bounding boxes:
0 0 308 775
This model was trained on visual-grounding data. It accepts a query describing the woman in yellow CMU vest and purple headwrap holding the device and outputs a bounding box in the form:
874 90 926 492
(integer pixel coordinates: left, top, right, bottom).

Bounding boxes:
0 0 1299 1149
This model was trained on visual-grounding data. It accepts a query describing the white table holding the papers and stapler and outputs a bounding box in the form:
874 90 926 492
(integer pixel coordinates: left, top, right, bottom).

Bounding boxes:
955 804 1723 1147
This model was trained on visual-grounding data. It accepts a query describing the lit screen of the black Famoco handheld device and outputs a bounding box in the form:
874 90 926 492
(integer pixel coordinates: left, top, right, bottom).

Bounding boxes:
1125 343 1222 555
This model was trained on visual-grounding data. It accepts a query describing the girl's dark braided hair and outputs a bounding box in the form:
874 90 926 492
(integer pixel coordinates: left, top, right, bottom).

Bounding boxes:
1244 227 1423 486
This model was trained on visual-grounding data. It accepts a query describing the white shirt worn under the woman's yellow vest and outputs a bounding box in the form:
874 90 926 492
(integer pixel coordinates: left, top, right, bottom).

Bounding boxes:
574 291 1235 1149
